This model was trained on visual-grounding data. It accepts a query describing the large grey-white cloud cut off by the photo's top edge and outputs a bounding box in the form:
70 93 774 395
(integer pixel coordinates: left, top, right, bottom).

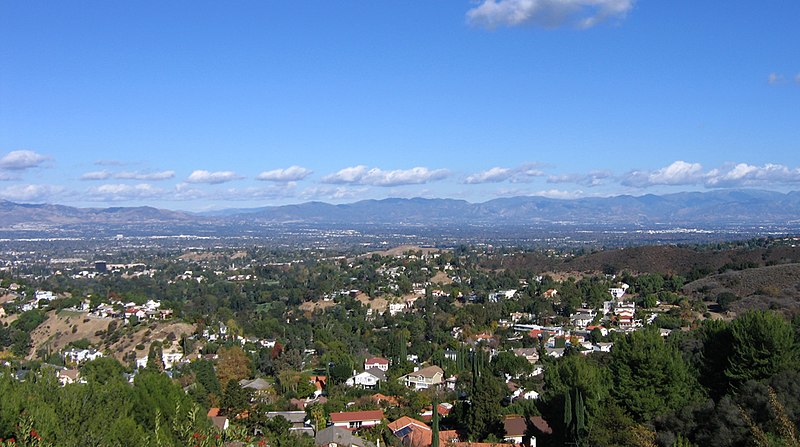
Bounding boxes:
467 0 635 29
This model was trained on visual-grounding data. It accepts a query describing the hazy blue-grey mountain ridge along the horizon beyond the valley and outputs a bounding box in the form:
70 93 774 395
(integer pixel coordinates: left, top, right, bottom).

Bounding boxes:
0 190 800 228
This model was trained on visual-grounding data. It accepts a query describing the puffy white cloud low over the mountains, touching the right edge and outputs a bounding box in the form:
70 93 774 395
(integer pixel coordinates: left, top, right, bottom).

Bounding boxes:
705 163 800 188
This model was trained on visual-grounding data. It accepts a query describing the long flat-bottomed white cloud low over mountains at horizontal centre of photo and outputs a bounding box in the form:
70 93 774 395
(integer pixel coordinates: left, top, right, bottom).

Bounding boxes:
322 165 450 186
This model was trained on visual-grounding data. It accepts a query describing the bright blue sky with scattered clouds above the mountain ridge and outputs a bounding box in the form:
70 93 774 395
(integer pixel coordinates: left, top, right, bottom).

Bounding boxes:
0 0 800 210
